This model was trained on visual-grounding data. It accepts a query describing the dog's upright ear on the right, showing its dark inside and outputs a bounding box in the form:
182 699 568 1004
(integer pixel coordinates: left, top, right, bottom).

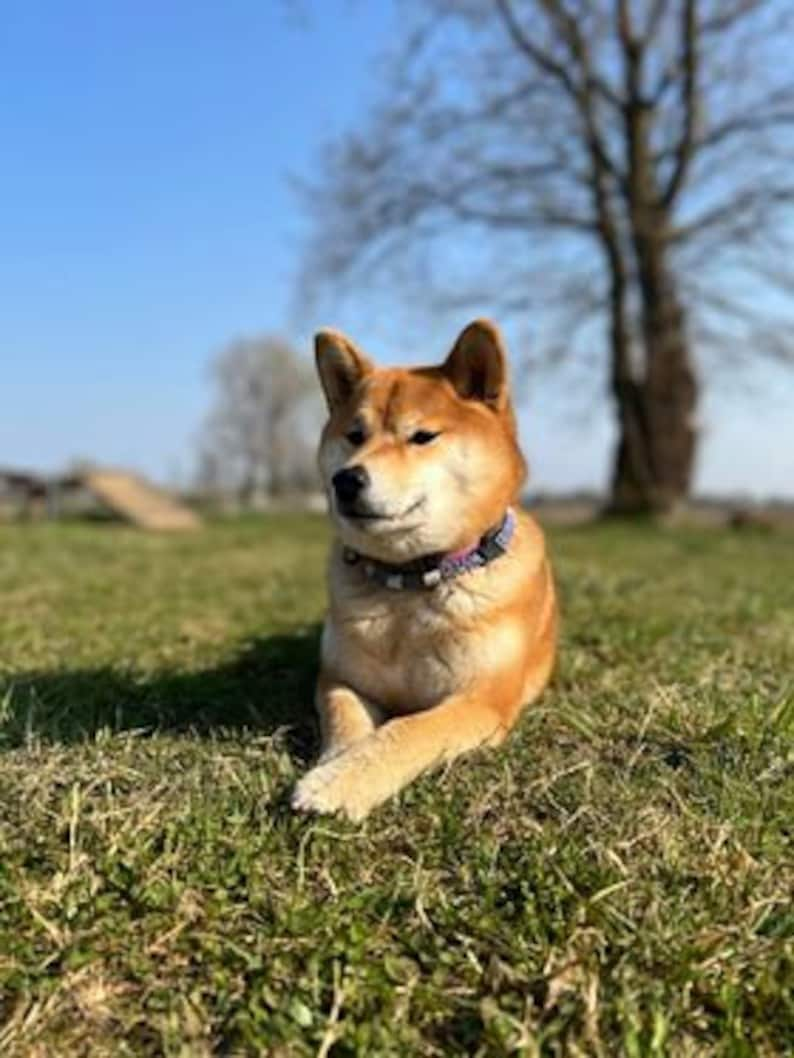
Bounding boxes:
443 320 509 412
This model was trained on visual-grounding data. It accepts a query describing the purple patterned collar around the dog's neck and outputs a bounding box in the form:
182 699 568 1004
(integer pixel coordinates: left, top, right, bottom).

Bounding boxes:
342 507 516 591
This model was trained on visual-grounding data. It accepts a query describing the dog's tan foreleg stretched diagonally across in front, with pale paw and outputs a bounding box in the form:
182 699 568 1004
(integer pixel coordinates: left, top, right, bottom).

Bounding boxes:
292 688 506 820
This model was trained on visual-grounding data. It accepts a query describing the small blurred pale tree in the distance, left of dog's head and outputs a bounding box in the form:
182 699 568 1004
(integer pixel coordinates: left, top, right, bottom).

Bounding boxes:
198 336 318 505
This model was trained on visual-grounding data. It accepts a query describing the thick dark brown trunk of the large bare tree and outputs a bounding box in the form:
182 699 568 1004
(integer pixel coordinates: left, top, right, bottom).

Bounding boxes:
610 240 698 514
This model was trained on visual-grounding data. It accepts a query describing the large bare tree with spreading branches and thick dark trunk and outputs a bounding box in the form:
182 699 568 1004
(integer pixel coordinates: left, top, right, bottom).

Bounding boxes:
303 0 794 511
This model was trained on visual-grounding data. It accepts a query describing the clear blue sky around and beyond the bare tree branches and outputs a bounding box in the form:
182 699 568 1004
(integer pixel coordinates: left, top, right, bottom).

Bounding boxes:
0 0 794 496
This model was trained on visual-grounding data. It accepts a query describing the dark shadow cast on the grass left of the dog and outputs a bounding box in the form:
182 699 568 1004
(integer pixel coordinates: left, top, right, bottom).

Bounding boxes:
0 625 320 760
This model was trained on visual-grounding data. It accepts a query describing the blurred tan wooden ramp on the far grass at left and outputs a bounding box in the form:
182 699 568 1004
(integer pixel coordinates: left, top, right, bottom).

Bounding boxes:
74 470 201 532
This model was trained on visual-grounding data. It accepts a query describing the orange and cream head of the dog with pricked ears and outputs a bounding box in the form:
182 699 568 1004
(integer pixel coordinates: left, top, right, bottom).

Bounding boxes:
315 320 525 563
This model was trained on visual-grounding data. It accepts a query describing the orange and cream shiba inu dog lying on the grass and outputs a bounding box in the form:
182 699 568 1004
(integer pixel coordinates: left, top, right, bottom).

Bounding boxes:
292 320 557 820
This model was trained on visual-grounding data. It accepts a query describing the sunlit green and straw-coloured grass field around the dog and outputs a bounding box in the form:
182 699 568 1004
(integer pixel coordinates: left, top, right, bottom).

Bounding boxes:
0 517 794 1058
